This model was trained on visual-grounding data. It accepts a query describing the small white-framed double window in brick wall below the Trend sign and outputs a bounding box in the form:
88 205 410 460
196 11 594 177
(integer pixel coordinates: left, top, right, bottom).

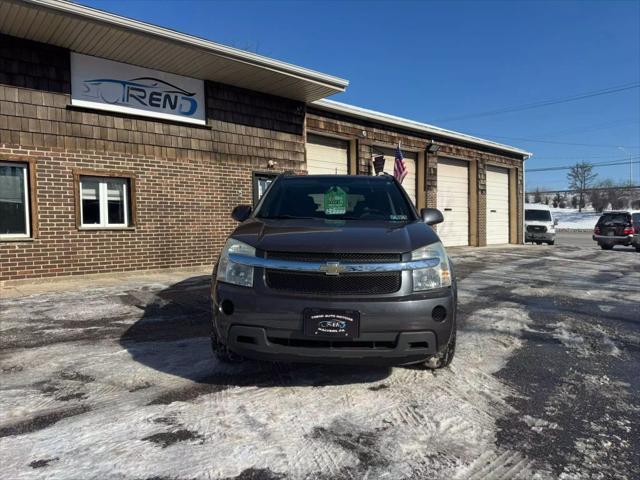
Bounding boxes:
79 175 132 228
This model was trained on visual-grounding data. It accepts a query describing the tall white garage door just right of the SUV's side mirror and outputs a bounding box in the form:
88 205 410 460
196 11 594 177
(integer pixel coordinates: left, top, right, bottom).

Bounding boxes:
438 160 469 247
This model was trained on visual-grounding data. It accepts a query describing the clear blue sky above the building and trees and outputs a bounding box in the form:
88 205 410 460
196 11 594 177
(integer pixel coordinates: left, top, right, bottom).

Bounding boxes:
79 0 640 191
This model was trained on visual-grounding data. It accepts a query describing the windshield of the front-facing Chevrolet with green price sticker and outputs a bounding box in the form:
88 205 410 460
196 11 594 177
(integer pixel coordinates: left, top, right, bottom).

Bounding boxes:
256 176 416 222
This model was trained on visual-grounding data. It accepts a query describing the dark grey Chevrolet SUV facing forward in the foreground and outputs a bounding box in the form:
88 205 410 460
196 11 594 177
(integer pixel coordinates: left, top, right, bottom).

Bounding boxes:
211 174 456 368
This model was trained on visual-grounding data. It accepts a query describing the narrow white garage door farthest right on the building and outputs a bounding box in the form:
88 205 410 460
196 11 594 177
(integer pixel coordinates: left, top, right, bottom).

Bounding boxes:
487 166 509 245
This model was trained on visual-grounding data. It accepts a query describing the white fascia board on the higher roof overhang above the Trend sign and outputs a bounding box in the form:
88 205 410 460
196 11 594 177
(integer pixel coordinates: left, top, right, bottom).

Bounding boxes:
22 0 349 91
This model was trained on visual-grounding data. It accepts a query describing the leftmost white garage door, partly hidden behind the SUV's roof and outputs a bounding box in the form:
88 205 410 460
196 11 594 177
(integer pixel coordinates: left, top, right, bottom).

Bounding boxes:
307 134 349 175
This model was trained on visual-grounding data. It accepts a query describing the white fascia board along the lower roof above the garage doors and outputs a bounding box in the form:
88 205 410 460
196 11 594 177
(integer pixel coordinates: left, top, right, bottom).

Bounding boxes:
311 99 533 160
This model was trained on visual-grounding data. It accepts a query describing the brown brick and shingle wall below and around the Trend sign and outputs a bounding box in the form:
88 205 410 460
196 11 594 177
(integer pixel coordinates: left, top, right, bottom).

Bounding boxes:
0 36 305 280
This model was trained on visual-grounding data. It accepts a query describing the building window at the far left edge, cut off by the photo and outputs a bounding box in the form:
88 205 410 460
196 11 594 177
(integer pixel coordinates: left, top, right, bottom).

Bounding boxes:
0 162 31 239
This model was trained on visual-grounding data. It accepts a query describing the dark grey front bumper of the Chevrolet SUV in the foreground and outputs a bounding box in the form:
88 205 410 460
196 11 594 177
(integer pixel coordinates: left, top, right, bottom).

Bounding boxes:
212 282 456 365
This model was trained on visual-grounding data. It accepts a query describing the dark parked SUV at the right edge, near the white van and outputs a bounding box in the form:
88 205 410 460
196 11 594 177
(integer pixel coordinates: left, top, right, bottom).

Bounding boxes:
593 210 640 252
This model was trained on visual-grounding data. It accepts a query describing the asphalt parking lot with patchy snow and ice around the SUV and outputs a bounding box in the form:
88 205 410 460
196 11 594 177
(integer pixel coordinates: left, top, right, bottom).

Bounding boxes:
0 246 640 480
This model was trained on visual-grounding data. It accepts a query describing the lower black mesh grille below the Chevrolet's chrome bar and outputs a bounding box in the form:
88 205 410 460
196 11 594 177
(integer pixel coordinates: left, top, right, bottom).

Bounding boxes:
266 270 402 295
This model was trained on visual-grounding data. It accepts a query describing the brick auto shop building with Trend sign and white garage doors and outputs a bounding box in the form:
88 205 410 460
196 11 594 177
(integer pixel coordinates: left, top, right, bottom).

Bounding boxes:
0 0 529 281
